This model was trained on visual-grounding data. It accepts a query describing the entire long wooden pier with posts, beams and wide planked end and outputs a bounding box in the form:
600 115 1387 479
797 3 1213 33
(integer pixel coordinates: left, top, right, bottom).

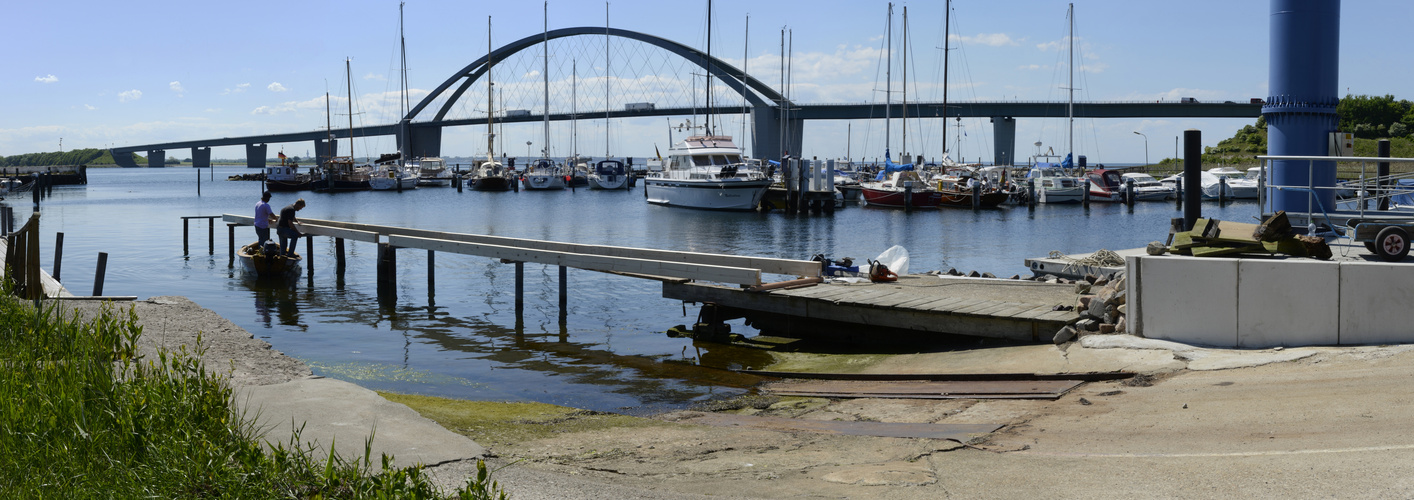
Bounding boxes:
222 213 1076 342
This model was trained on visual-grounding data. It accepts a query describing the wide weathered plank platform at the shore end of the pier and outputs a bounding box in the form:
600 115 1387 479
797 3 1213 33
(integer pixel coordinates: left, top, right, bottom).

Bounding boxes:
663 275 1077 342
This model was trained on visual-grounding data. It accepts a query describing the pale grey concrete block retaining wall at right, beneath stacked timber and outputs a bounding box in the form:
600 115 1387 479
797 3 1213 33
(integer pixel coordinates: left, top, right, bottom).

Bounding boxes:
1126 256 1414 349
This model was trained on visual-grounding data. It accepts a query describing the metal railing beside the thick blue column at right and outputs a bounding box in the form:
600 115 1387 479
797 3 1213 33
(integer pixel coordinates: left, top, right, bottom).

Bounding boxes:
1257 155 1414 219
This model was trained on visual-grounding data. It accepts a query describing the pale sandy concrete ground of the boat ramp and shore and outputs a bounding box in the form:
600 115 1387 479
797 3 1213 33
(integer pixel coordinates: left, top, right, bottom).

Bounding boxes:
64 297 1414 499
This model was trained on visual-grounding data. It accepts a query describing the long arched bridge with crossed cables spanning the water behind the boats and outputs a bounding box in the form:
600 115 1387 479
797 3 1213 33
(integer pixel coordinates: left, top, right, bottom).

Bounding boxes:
112 27 1261 167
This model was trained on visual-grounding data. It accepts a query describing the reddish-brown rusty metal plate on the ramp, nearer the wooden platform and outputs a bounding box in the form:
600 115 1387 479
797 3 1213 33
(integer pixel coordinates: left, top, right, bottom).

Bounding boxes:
762 380 1082 400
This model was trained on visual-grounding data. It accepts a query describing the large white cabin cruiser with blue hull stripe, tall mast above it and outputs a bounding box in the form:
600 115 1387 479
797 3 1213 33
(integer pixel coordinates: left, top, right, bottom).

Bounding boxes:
643 0 771 210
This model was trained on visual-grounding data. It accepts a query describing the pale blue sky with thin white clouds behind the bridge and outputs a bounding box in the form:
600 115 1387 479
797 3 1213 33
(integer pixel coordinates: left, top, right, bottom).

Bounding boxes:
0 0 1414 162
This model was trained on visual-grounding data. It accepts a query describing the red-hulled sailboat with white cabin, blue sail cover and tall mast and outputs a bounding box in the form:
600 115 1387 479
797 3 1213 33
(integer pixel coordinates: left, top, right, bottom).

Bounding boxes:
860 3 939 209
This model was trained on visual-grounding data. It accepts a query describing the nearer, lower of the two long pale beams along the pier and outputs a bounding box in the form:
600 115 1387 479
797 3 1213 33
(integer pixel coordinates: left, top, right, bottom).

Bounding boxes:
387 234 761 285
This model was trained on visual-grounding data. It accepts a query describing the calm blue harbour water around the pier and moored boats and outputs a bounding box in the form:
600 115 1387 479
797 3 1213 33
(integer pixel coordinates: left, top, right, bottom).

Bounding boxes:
16 167 1257 411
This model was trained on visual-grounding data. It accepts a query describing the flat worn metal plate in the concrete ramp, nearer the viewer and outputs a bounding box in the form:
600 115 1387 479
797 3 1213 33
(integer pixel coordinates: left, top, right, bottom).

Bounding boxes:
674 411 1001 442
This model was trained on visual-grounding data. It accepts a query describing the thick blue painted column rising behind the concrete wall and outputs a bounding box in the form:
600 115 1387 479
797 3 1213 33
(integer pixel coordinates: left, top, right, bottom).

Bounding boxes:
1261 0 1340 213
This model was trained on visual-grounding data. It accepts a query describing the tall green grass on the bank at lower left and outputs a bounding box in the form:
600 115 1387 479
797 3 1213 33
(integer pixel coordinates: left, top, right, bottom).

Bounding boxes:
0 295 505 499
